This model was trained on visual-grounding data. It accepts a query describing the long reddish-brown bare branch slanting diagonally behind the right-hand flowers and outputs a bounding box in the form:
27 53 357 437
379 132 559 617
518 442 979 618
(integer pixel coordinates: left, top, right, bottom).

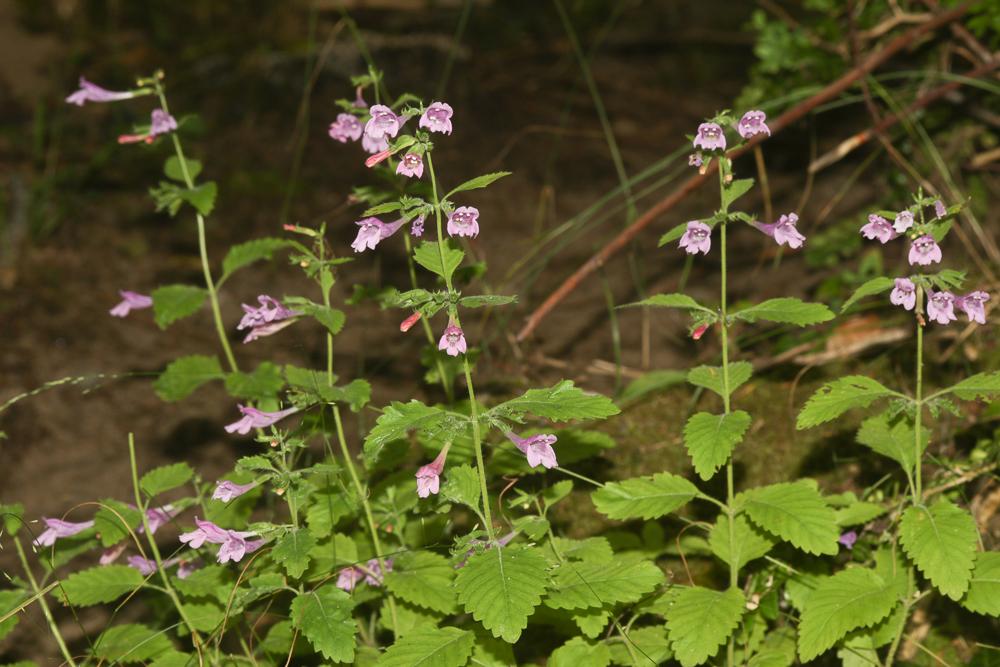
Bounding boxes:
517 2 970 342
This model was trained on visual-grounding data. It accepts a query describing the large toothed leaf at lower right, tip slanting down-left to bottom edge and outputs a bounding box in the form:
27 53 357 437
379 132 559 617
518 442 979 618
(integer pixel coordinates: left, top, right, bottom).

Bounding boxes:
799 567 899 662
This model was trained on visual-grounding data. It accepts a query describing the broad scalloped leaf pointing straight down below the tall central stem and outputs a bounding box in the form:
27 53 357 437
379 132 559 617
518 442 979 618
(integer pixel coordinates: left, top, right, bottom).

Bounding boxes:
455 546 548 644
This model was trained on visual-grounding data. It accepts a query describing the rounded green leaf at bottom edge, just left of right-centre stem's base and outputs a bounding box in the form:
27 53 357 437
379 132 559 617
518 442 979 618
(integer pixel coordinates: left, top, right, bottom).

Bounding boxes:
667 586 746 667
